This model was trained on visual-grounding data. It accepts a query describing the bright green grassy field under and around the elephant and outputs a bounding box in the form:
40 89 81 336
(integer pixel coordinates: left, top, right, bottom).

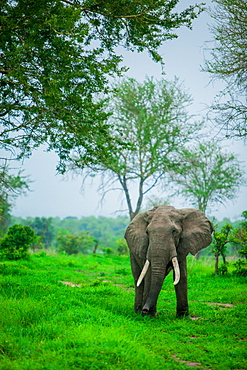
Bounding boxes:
0 253 247 370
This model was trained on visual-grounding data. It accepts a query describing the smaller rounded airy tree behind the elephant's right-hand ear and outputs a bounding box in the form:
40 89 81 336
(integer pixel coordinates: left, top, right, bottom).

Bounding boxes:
171 142 244 213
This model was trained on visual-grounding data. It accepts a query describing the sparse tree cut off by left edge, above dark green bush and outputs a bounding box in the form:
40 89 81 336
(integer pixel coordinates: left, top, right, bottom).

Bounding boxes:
0 161 29 236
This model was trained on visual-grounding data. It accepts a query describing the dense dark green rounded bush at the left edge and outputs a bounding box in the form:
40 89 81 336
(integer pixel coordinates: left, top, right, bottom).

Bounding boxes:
0 225 36 260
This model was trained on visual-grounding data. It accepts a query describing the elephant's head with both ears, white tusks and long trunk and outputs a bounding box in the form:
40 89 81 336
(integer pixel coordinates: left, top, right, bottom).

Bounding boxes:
125 206 212 311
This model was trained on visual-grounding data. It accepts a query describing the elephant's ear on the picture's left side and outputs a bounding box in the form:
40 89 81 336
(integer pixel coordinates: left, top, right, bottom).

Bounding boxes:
124 211 153 259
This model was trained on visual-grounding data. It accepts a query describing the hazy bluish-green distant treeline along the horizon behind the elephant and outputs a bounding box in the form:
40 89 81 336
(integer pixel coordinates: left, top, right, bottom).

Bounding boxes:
11 212 243 254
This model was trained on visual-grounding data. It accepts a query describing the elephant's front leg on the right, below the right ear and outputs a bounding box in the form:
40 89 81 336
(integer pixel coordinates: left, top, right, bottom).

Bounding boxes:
175 257 189 317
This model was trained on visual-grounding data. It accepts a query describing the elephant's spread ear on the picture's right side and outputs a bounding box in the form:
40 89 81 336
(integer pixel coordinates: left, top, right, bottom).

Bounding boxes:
178 208 213 256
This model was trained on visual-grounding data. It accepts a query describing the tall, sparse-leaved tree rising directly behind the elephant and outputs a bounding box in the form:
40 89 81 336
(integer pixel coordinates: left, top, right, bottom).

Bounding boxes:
72 78 200 219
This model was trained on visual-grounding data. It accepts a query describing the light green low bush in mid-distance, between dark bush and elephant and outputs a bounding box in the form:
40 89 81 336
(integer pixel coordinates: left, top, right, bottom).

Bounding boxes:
57 232 95 254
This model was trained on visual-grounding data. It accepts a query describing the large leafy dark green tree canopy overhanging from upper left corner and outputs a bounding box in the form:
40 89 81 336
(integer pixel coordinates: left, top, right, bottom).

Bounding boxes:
0 0 203 165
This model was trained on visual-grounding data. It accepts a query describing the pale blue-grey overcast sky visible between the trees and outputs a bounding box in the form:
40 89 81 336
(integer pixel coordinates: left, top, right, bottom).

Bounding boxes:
12 1 247 220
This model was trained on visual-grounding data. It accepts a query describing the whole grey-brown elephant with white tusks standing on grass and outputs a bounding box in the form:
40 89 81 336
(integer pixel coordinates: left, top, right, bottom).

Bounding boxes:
124 205 213 317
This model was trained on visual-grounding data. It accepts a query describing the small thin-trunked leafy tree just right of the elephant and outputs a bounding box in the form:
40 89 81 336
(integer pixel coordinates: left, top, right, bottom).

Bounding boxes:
212 224 232 275
